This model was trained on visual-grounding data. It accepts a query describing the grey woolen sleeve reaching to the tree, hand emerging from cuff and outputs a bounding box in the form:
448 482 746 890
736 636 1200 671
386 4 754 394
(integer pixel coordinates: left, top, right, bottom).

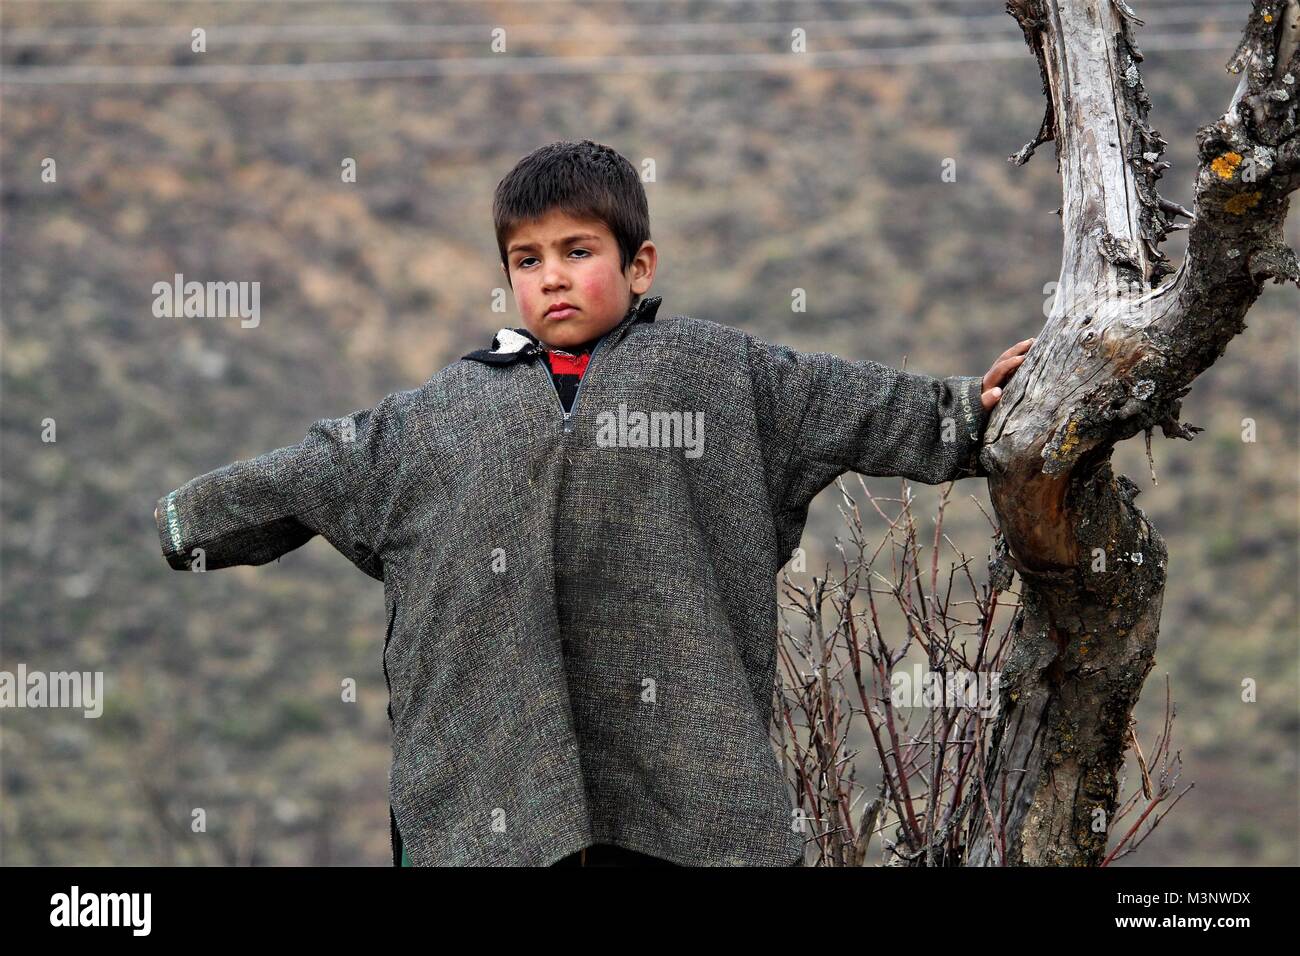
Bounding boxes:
746 333 988 520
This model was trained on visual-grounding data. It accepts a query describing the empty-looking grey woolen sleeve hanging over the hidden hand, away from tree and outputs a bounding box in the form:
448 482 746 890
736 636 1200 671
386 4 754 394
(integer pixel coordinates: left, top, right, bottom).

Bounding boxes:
156 393 411 580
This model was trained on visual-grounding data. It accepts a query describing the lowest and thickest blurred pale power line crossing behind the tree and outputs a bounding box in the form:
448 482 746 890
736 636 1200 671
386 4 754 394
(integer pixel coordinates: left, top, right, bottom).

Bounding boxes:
0 34 1235 86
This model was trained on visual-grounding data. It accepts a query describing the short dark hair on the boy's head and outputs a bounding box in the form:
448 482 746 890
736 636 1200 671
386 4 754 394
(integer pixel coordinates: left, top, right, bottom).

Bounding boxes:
491 139 650 299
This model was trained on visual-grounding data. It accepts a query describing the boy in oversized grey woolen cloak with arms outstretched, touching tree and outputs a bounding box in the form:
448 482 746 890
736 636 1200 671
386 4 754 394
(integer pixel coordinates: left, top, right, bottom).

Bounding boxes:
155 140 1032 866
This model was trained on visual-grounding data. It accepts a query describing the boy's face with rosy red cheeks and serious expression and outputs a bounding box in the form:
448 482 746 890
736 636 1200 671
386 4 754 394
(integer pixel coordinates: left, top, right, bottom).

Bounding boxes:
502 209 658 349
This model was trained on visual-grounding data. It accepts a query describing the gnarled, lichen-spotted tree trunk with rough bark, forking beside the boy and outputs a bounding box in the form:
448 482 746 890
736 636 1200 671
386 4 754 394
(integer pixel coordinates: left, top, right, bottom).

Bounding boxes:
946 0 1300 866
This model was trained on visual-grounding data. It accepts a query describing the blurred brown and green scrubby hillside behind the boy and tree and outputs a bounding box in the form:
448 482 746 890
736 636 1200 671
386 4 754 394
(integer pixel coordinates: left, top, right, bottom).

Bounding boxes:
0 0 1300 865
